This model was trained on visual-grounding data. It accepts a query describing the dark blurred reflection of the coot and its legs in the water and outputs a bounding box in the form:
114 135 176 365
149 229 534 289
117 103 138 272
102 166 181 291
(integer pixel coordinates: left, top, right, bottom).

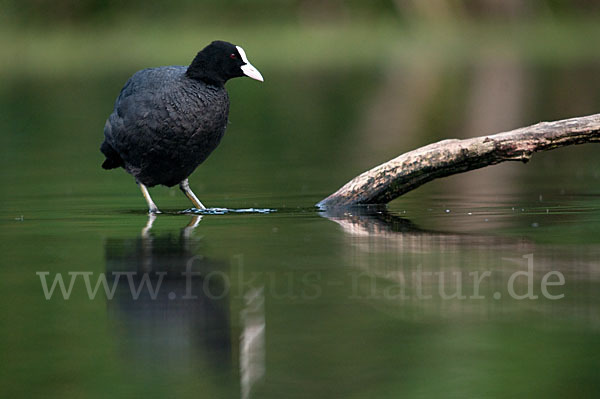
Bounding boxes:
100 215 237 378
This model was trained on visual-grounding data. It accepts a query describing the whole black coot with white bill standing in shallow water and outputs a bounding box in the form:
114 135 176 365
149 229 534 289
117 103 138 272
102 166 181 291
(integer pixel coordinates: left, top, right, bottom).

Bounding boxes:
100 41 263 213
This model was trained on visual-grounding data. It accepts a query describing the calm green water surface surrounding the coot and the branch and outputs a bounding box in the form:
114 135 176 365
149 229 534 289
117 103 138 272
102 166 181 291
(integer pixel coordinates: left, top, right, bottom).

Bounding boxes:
0 61 600 398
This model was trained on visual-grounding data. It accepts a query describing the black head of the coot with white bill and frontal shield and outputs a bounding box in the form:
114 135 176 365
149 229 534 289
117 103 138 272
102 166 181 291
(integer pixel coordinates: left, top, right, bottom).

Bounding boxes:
186 40 263 86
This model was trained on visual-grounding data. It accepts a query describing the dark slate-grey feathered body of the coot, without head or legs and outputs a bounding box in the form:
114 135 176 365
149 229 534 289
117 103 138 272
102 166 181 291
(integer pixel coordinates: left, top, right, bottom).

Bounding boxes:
102 66 229 187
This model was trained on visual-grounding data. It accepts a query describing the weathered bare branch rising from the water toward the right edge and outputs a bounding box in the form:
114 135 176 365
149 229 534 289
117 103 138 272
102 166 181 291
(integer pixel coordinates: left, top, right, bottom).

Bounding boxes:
317 114 600 208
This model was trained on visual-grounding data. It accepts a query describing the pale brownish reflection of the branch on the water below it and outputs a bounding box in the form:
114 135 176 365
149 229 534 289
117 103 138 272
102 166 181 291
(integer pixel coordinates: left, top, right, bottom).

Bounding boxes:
320 206 600 328
